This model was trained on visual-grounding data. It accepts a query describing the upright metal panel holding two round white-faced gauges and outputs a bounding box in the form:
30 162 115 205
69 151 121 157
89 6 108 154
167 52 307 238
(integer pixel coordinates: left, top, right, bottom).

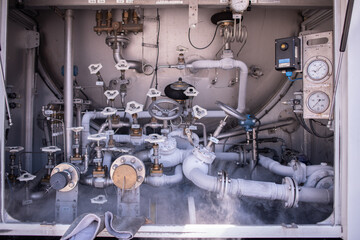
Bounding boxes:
303 32 334 119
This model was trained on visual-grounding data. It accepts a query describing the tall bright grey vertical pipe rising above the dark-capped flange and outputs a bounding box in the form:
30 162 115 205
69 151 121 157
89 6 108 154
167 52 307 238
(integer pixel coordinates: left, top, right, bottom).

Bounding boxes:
64 9 74 161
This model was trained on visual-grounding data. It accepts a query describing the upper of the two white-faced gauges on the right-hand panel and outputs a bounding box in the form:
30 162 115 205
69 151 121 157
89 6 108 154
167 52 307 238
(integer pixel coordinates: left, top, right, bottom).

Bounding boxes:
305 56 332 82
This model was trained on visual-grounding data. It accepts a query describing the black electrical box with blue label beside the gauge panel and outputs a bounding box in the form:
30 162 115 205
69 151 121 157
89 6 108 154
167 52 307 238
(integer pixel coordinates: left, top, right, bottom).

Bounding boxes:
275 37 301 71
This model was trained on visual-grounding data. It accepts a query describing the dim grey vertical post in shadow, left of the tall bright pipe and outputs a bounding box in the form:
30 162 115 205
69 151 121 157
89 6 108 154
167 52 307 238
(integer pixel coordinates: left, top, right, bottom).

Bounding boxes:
25 48 35 172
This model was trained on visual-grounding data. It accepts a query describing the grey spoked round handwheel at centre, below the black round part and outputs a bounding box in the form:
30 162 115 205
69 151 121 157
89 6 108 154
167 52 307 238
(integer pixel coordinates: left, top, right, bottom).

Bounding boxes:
149 98 182 120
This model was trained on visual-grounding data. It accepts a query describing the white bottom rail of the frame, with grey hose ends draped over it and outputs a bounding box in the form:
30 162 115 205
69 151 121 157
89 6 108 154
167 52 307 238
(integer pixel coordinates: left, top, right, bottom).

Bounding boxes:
0 224 343 238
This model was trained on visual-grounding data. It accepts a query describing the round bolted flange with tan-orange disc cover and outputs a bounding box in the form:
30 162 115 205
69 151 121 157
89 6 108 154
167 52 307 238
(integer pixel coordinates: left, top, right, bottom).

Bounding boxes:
110 155 145 190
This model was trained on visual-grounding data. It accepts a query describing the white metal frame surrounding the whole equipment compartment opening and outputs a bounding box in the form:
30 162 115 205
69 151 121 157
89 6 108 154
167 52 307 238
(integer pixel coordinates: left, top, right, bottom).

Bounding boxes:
0 0 354 239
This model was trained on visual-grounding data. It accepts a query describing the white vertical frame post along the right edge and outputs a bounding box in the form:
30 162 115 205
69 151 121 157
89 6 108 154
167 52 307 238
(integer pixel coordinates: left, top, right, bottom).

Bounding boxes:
337 1 360 239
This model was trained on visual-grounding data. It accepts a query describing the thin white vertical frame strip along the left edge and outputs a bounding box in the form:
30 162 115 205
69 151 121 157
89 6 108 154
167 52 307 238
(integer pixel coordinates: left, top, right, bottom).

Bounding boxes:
0 1 8 222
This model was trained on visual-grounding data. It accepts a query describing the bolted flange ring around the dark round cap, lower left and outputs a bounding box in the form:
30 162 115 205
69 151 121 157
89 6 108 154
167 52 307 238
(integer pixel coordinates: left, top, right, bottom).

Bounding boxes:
50 163 80 192
